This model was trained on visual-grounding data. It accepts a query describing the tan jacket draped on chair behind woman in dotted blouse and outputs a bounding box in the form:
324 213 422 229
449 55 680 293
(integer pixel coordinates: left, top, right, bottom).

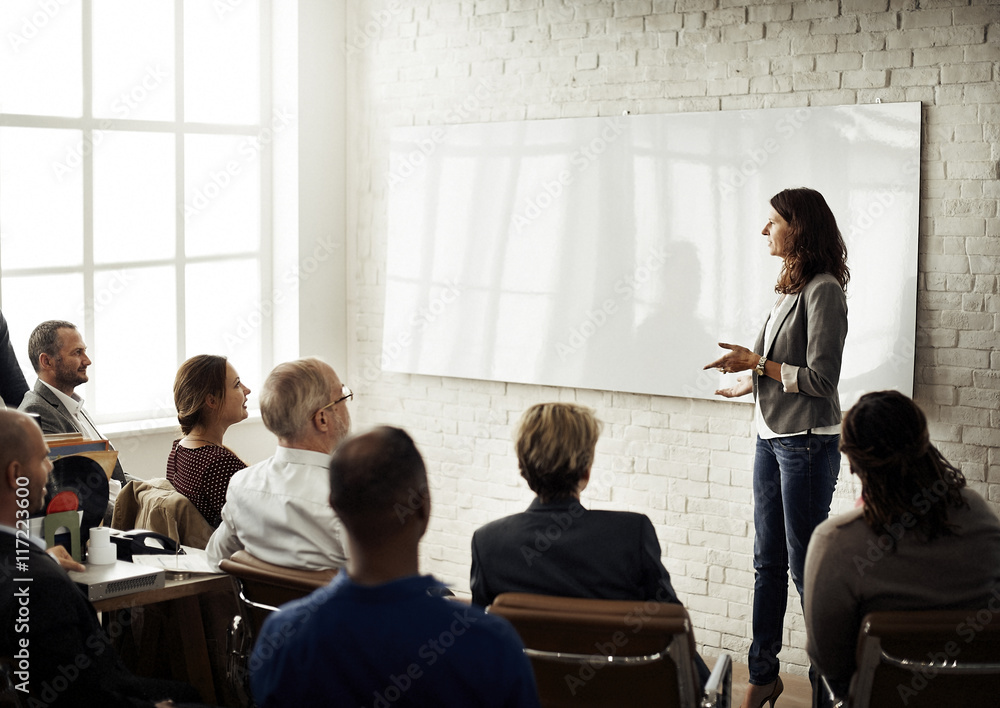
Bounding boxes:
111 477 215 548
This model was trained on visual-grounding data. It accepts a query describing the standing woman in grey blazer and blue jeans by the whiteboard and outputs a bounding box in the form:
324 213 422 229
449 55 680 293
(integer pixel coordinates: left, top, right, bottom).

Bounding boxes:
705 188 850 708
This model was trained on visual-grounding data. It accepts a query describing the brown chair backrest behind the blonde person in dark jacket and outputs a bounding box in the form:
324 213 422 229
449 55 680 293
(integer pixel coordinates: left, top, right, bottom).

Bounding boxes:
489 593 700 708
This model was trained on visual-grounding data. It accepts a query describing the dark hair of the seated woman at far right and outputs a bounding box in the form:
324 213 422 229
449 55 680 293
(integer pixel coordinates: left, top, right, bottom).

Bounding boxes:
840 391 967 547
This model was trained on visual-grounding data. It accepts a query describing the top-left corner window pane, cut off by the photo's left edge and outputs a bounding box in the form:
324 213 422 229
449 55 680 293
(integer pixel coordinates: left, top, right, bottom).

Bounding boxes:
0 0 83 116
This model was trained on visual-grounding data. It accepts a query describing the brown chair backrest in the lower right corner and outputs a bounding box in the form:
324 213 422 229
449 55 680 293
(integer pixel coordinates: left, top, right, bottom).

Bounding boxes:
850 609 1000 708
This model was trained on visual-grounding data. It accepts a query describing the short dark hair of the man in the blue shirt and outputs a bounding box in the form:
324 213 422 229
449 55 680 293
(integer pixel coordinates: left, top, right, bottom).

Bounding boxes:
330 426 429 543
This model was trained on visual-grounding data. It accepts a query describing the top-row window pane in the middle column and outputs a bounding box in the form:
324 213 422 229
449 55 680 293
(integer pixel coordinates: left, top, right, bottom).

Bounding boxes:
93 0 174 120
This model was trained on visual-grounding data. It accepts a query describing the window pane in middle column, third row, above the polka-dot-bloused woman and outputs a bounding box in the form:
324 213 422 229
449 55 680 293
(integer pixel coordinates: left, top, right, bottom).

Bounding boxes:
88 266 177 420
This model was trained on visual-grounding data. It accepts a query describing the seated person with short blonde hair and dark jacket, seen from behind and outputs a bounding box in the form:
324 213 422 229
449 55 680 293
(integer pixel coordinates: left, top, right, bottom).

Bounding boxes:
471 403 680 606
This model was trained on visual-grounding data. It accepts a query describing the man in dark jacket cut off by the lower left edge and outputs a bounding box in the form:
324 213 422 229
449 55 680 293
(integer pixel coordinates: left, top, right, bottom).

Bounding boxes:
0 410 204 708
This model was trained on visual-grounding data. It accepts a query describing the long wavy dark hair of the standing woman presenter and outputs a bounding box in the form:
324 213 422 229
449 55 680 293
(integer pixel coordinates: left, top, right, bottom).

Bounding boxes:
771 187 851 294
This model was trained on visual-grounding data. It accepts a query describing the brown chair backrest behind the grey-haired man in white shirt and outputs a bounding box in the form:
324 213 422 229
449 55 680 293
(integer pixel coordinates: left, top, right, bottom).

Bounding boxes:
219 551 337 637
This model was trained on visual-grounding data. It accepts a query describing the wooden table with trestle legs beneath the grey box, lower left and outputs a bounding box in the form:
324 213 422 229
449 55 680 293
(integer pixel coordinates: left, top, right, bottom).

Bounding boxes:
93 575 233 705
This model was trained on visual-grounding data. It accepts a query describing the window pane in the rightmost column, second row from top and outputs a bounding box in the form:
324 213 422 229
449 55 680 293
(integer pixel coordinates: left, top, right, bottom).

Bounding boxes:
184 135 260 256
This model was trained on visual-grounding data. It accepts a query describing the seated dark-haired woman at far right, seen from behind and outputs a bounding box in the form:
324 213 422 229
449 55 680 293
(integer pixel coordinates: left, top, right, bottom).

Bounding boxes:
805 391 1000 696
